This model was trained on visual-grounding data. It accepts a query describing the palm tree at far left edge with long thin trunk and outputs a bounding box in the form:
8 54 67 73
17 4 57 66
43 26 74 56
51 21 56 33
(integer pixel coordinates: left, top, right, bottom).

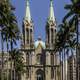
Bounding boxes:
0 0 7 80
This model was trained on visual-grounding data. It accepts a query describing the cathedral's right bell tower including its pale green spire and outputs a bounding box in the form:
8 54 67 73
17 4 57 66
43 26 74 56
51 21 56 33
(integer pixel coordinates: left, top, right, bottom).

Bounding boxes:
46 0 56 49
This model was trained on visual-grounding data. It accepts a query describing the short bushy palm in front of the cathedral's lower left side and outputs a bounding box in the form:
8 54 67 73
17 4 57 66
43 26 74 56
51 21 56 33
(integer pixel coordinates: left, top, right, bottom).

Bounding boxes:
11 49 24 80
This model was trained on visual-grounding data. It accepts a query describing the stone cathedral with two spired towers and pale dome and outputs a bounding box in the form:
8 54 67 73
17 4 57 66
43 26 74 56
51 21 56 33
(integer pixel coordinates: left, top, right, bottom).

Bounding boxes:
21 0 60 80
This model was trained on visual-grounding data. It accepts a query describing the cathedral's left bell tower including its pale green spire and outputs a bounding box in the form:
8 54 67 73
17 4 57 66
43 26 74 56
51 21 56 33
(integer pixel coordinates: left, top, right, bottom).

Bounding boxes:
22 0 33 48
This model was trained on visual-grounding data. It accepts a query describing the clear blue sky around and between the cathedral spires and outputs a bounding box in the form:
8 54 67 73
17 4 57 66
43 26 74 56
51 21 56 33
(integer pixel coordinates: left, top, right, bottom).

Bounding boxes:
0 0 70 49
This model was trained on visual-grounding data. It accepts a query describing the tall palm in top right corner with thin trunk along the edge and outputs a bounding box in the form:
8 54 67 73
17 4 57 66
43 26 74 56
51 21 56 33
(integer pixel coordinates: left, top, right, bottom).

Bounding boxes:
63 0 80 80
